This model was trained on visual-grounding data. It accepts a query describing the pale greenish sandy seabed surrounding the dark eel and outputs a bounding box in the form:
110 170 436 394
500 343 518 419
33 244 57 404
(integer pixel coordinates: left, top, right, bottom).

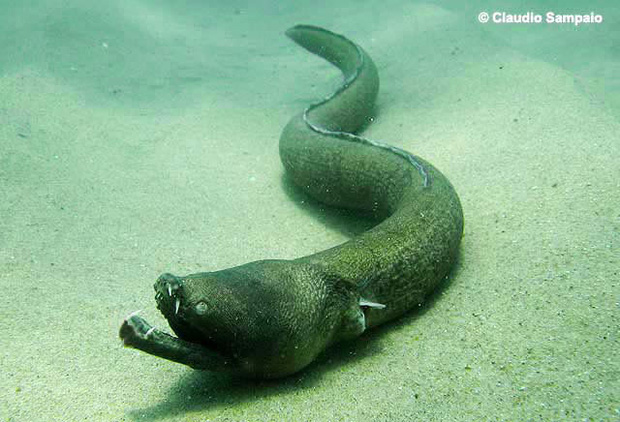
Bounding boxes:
0 0 620 422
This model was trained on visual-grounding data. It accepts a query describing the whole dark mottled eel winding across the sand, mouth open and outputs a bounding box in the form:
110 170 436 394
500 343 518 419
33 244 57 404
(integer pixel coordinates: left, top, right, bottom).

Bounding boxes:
120 25 463 378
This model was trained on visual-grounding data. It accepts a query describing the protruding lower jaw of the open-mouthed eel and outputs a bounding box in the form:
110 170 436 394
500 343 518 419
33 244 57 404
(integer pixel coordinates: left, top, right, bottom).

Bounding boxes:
119 312 240 373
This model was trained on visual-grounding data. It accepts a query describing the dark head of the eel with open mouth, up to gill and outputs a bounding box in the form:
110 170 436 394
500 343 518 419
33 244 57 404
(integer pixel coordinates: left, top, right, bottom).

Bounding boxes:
120 260 365 378
